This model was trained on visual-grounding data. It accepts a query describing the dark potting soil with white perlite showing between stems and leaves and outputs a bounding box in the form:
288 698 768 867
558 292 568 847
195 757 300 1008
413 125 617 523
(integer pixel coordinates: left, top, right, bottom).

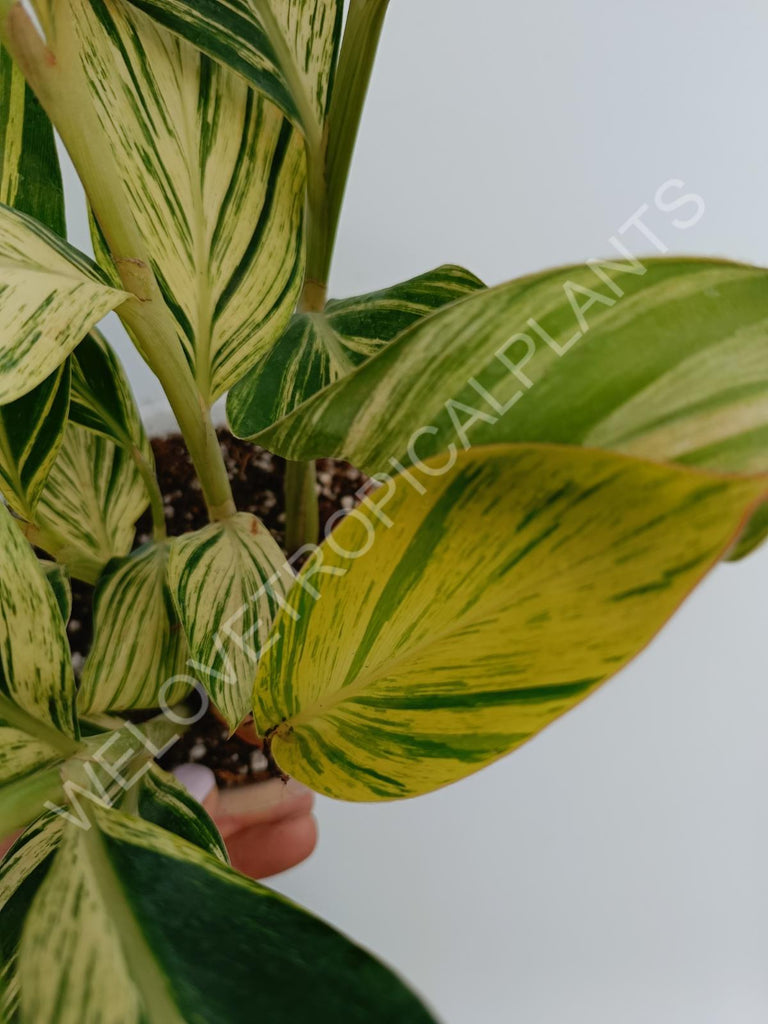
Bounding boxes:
68 430 366 786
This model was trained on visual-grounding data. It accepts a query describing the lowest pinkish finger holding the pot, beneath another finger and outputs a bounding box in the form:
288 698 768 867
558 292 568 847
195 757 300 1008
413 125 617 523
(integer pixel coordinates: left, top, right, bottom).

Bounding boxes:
226 814 317 879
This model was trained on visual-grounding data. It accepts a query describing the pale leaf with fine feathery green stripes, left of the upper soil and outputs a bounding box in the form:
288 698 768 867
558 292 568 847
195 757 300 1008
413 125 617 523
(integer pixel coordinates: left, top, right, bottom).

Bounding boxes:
30 423 147 583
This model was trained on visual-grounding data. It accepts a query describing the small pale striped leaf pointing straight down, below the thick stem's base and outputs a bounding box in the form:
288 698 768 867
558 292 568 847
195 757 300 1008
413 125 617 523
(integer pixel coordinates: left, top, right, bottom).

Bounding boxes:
168 512 292 730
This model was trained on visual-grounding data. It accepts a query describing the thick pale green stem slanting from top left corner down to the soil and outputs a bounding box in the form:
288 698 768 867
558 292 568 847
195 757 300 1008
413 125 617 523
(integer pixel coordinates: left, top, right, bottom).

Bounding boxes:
0 0 236 520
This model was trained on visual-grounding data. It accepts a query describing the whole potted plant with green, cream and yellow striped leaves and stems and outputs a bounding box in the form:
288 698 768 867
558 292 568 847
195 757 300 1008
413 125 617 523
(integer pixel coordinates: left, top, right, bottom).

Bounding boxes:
0 0 768 1024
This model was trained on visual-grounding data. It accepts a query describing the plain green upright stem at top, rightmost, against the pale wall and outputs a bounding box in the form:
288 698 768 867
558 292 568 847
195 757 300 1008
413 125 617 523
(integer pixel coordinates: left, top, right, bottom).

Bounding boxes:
326 0 389 276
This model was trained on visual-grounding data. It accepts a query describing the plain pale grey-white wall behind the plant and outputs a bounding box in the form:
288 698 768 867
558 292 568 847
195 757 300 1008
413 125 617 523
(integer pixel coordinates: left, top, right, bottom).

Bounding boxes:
61 0 768 1024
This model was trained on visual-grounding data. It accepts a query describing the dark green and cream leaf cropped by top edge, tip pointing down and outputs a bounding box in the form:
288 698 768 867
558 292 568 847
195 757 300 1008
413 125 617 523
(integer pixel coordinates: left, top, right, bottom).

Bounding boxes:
126 0 343 140
